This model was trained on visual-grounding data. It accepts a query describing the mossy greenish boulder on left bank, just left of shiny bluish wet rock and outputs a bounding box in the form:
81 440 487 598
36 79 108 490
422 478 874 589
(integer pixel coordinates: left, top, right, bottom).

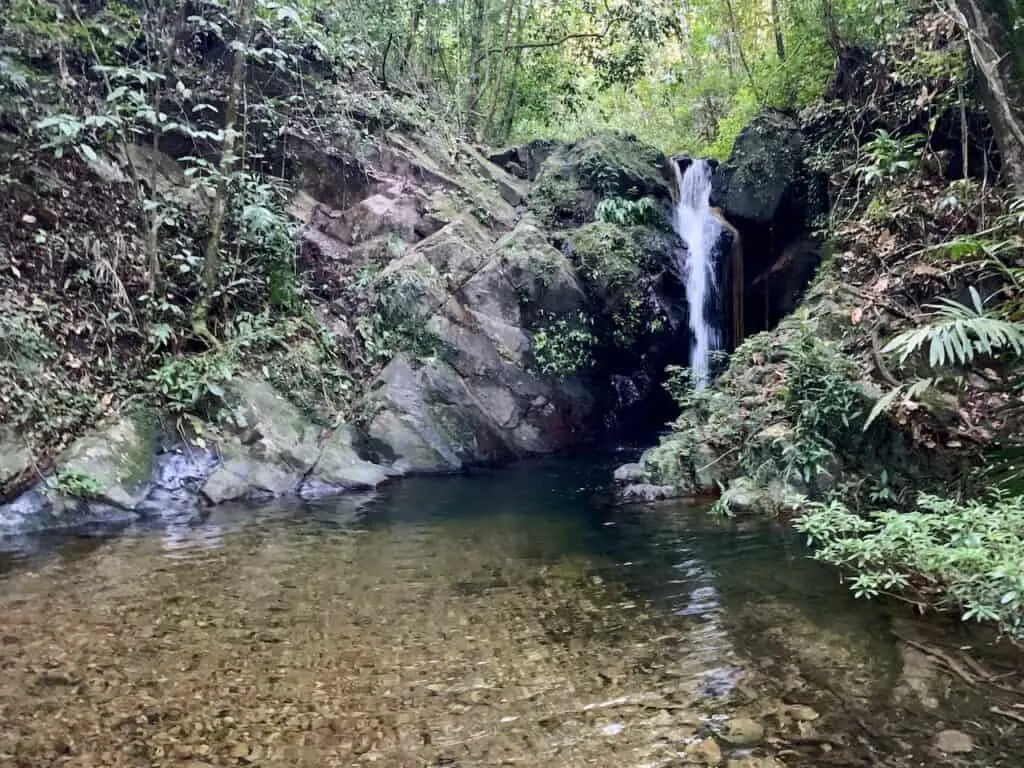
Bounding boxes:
56 411 158 509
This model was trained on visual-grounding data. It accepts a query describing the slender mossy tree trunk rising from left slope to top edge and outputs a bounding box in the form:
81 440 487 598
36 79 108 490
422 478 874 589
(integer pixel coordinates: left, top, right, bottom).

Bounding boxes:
193 0 256 345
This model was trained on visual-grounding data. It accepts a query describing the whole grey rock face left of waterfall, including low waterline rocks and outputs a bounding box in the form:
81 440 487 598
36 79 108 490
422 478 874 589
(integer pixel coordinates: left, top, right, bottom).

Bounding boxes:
0 134 688 524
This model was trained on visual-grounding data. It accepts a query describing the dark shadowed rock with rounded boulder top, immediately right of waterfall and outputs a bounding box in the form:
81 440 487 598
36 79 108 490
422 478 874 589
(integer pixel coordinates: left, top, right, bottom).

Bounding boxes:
711 111 828 335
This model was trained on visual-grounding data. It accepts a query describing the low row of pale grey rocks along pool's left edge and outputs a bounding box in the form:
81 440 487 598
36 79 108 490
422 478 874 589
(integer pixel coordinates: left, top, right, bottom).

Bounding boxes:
0 376 401 532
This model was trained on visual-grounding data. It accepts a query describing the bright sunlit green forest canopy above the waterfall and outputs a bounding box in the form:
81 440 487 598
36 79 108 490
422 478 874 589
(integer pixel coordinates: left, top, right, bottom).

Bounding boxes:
314 0 909 155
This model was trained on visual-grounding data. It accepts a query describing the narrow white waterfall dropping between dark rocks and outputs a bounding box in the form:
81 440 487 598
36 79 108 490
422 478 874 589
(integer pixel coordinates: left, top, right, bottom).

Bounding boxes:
672 160 722 389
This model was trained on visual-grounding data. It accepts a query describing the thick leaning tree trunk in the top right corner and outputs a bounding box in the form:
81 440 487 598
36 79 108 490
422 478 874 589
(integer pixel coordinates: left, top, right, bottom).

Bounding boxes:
949 0 1024 193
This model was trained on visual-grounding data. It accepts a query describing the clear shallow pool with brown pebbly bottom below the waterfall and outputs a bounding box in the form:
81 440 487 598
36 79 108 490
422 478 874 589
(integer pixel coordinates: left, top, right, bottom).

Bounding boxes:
0 459 1024 768
